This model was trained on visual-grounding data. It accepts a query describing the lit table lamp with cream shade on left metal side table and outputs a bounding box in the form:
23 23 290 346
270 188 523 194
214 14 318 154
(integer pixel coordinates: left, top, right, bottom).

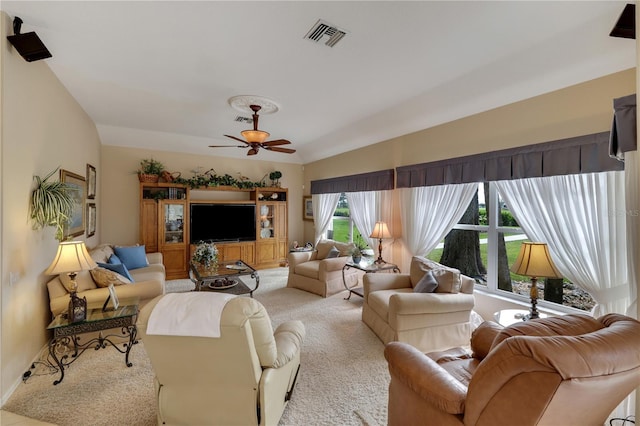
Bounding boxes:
44 241 98 322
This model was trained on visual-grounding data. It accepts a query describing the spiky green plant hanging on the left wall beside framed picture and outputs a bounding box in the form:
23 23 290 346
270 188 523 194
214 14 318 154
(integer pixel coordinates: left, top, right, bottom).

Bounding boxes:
30 167 73 241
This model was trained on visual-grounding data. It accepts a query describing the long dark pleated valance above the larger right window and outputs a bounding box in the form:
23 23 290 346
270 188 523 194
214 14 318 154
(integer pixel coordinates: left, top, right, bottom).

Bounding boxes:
396 132 624 188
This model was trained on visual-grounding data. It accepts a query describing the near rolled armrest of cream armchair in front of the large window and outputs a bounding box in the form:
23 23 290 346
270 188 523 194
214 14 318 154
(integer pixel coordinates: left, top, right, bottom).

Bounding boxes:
389 293 475 317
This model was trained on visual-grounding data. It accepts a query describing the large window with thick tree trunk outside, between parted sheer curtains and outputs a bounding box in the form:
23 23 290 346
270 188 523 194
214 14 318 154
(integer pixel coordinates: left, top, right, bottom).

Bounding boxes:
427 183 595 311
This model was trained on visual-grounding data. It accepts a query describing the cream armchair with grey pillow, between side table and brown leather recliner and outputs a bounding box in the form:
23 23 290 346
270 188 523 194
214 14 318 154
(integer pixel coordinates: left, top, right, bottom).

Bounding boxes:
362 256 477 352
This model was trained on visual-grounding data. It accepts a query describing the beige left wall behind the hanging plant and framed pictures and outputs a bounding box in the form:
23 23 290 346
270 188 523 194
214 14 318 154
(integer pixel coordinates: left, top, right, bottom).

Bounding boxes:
0 13 101 401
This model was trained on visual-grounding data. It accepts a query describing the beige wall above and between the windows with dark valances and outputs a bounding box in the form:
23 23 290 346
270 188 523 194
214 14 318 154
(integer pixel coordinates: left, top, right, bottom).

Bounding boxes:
304 69 636 268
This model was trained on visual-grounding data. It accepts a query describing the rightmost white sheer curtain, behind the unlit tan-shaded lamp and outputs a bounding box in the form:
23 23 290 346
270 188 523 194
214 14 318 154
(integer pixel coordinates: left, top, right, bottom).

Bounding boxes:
496 172 631 317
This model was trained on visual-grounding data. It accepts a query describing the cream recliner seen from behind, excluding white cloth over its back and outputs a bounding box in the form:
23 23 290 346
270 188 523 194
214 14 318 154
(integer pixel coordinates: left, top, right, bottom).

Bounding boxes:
137 293 305 426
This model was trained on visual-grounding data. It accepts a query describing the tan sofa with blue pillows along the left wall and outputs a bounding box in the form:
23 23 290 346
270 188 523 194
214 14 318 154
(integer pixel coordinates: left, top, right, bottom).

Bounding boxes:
47 244 165 317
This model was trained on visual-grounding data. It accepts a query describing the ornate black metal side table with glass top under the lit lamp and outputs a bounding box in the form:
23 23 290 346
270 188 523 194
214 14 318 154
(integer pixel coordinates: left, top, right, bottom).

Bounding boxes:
23 300 138 385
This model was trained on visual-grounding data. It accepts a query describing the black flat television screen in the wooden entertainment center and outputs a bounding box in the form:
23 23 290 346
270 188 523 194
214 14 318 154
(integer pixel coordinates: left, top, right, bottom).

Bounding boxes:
190 203 256 244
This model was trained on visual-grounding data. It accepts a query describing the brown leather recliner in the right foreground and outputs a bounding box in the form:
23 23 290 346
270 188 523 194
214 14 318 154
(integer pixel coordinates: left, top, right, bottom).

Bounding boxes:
385 314 640 426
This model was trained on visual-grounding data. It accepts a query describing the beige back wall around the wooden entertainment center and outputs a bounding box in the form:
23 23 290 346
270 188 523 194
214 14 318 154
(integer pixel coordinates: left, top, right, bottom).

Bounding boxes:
100 146 302 244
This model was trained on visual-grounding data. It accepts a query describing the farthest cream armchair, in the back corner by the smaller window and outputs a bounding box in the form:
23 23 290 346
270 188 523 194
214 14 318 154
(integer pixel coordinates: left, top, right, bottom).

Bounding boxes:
287 240 364 297
